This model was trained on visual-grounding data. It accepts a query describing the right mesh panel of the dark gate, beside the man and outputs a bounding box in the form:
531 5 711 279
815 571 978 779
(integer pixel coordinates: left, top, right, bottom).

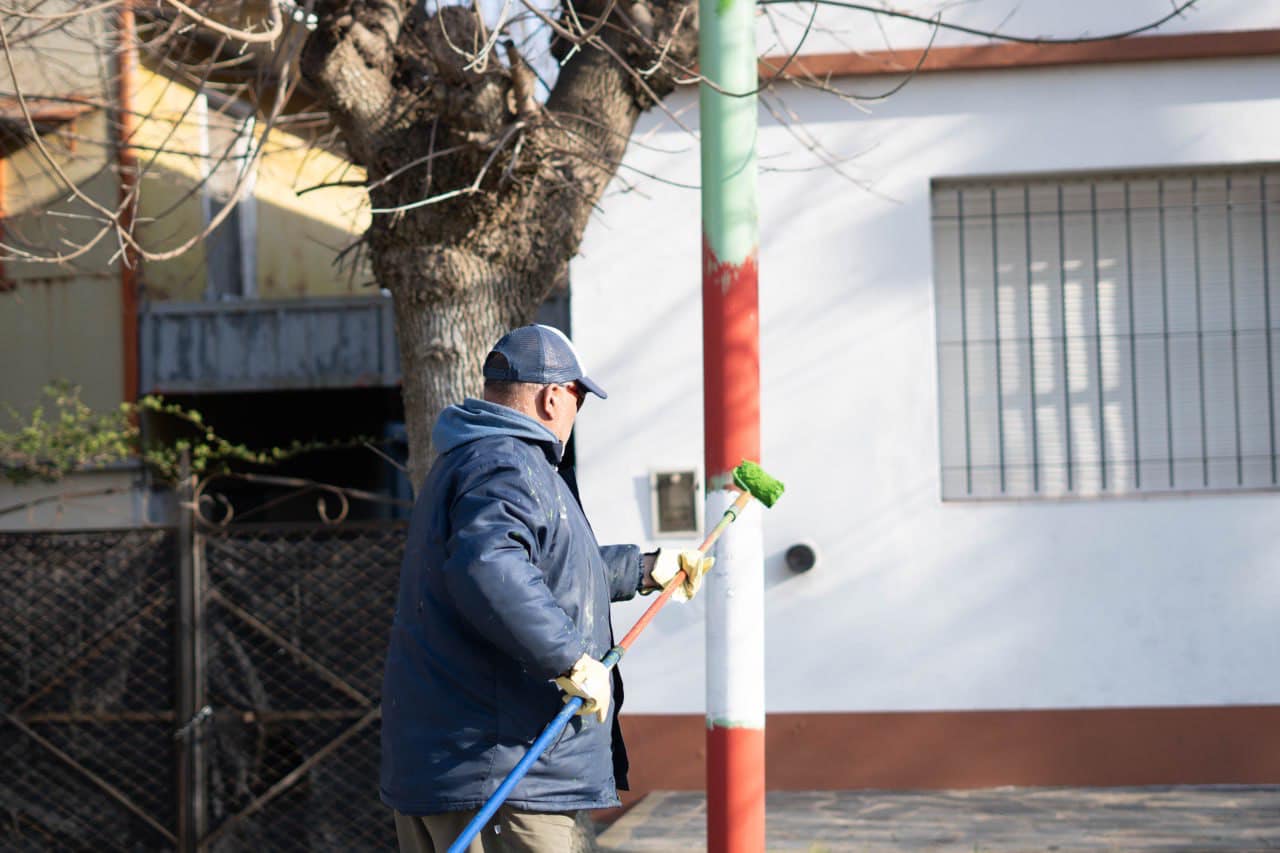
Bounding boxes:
197 525 404 853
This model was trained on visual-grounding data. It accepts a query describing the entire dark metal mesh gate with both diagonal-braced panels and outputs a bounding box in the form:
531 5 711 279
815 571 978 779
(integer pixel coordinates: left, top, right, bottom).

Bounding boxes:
0 504 404 853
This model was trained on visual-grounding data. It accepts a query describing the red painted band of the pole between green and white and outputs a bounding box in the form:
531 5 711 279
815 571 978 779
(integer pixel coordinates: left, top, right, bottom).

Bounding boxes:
703 237 760 488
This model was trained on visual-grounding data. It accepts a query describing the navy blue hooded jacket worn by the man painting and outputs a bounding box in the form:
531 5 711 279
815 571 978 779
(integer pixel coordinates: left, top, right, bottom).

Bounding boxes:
381 400 641 815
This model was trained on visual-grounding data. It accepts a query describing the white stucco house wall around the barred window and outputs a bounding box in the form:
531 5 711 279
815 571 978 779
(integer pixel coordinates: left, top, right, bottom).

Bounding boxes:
572 54 1280 713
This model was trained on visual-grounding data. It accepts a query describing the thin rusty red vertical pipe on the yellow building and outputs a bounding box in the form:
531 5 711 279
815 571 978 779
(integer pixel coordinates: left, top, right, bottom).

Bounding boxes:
115 0 141 402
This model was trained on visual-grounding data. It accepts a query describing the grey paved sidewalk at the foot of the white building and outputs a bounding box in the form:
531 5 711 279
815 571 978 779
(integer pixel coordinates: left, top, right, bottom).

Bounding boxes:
599 786 1280 853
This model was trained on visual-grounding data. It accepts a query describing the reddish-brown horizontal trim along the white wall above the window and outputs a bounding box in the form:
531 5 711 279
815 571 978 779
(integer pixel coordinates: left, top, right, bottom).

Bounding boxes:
760 29 1280 78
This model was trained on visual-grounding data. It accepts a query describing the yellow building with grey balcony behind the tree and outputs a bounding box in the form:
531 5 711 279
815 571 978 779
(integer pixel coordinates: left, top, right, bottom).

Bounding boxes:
0 12 401 528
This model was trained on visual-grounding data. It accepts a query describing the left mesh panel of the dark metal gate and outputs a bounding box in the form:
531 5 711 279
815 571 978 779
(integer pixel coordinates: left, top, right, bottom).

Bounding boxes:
0 530 177 850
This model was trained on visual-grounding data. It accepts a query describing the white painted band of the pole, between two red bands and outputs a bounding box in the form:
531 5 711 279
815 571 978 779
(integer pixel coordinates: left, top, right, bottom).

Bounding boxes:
705 489 764 729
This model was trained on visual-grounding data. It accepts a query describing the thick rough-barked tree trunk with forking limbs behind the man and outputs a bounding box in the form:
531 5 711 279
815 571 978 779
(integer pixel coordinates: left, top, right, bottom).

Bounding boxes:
302 0 698 489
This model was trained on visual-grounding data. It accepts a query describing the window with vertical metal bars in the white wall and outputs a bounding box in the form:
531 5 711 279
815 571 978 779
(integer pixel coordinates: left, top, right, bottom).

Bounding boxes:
932 165 1280 500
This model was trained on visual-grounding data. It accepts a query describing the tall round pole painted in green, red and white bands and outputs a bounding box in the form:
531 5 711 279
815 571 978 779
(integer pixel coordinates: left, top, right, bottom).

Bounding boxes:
699 0 764 853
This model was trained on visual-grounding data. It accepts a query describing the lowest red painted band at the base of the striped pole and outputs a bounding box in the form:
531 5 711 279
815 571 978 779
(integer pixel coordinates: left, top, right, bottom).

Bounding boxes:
707 726 765 853
